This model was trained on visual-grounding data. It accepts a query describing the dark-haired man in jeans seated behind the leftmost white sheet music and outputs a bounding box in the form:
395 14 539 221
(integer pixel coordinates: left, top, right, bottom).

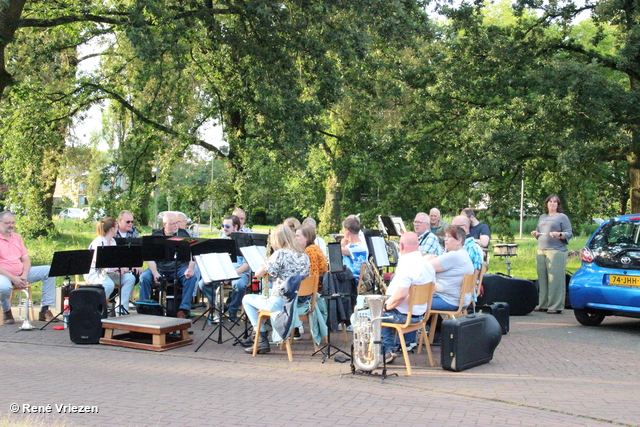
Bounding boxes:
199 215 251 322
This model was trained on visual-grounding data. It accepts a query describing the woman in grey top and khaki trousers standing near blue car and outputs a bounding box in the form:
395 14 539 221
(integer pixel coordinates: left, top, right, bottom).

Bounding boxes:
531 194 573 314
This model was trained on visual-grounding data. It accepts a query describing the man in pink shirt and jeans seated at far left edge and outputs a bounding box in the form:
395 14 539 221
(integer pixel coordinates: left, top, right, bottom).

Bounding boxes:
0 211 56 325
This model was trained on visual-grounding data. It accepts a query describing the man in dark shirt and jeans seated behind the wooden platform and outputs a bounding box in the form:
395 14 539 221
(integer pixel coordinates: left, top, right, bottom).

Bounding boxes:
140 212 199 319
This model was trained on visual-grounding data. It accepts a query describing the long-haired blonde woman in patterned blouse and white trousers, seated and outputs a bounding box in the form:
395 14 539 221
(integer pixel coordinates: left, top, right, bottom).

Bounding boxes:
242 224 309 353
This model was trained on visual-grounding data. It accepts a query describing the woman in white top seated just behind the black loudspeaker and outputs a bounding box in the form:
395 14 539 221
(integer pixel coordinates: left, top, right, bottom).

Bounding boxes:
84 218 136 314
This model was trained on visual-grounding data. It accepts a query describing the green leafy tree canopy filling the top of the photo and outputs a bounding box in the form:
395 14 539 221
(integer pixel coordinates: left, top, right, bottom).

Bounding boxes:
0 0 640 234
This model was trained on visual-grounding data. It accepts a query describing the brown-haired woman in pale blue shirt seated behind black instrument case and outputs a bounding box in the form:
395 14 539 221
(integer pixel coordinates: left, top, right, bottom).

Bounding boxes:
429 225 474 311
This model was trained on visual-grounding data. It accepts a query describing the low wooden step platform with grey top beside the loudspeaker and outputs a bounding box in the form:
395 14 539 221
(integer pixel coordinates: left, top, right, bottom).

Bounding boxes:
100 314 193 351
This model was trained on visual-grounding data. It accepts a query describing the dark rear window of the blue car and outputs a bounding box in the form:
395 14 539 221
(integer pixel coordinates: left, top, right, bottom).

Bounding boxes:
589 221 640 270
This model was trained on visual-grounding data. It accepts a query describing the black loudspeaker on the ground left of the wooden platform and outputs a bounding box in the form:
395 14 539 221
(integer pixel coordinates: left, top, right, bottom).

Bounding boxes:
69 285 107 344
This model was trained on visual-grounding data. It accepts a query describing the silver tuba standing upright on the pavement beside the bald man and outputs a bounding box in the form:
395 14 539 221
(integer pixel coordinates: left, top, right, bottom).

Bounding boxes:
353 295 386 372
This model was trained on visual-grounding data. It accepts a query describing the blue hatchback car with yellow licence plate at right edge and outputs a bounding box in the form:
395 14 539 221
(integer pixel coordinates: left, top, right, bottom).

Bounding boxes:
569 214 640 326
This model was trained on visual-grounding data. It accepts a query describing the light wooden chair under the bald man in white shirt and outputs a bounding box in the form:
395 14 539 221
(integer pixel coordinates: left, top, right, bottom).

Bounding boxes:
381 282 435 375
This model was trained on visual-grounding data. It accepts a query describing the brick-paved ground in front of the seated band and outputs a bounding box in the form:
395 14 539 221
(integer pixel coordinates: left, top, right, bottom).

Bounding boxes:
0 309 640 426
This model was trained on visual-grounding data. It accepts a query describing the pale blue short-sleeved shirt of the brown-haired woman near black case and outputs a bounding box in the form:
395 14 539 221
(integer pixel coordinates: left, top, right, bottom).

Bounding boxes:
436 248 474 307
